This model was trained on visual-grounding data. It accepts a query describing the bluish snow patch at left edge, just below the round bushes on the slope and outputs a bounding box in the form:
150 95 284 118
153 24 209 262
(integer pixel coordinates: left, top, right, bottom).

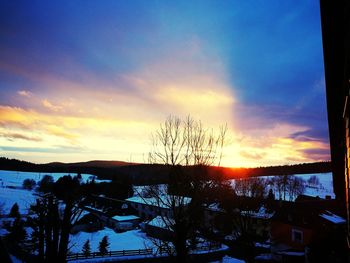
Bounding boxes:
0 188 36 214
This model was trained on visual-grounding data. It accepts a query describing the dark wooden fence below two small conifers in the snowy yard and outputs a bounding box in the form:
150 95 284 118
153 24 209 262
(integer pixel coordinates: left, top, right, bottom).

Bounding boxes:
66 249 153 261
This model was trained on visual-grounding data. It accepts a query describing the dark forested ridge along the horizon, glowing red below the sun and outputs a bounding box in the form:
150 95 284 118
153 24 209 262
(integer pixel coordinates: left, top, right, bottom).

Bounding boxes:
0 157 332 184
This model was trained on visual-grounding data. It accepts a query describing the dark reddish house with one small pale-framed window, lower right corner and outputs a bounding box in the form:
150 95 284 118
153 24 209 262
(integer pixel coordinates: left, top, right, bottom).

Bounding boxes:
270 198 346 258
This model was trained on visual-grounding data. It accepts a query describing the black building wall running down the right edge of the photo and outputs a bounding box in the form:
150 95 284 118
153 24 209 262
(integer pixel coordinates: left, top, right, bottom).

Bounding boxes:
320 0 350 241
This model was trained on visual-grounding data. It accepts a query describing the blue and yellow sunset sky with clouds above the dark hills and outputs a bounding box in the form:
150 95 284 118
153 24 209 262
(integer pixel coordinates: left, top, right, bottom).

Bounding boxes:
0 0 330 167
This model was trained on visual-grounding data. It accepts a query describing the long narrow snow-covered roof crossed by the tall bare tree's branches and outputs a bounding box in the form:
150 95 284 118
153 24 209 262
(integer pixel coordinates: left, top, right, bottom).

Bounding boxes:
125 195 192 208
